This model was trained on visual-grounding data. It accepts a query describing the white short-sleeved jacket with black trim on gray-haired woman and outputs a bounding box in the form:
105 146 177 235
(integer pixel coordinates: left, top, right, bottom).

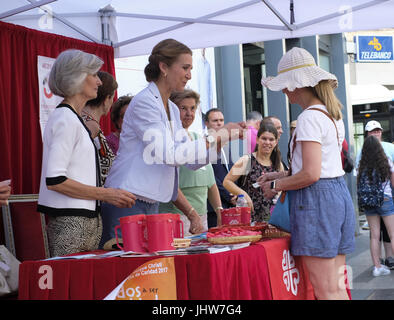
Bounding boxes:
37 104 100 217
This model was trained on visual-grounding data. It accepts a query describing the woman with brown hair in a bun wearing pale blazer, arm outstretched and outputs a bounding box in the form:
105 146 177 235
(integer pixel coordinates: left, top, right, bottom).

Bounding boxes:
103 39 245 248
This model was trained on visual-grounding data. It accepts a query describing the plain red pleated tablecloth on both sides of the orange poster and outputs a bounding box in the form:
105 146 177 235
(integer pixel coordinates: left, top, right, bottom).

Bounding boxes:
19 245 272 300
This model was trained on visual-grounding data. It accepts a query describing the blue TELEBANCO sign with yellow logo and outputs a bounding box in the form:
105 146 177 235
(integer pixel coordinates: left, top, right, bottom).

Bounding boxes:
356 36 393 62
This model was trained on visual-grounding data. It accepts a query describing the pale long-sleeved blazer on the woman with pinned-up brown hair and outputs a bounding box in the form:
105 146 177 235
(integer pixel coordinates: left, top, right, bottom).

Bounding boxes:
105 82 218 202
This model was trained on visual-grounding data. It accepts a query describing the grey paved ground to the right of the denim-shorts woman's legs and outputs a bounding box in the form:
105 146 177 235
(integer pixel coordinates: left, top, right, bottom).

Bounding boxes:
346 216 394 300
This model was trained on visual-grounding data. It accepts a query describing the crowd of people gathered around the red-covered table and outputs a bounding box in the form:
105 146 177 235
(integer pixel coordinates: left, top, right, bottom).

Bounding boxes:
13 39 388 299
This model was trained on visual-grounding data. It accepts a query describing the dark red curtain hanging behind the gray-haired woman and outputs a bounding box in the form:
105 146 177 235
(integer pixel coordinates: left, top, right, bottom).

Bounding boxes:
0 22 115 260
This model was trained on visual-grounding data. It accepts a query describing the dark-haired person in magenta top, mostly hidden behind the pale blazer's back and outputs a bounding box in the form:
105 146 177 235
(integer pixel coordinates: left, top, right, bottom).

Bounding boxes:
105 96 133 155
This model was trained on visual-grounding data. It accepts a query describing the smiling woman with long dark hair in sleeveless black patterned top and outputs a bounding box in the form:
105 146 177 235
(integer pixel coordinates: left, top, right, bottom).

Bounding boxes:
223 122 284 222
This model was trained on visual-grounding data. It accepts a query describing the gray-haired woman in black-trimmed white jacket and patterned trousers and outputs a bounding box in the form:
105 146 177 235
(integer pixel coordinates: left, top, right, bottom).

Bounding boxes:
37 50 135 256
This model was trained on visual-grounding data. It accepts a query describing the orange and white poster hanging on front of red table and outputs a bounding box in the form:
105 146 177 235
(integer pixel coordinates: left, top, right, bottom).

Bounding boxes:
104 257 177 300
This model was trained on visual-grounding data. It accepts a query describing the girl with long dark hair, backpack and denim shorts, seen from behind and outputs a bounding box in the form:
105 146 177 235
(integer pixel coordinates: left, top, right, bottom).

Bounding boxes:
357 136 394 277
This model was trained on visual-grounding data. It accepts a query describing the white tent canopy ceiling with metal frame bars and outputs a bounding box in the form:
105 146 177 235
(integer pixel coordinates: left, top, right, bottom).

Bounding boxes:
0 0 394 57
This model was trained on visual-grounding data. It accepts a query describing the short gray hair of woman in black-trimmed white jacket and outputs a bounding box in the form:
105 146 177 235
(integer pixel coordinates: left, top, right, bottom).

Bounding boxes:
48 49 104 97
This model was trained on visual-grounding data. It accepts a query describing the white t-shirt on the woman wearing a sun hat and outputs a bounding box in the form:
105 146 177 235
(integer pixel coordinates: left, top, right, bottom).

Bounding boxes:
290 105 345 178
